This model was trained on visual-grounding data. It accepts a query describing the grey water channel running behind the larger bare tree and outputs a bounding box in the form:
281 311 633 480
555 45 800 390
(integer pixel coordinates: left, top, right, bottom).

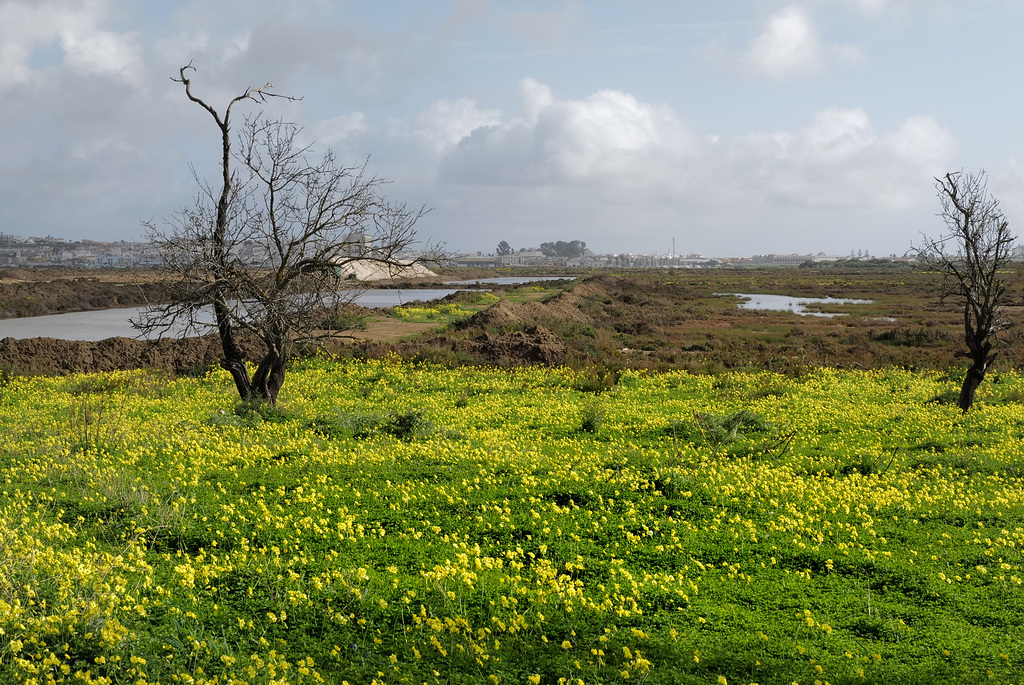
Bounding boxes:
0 276 571 341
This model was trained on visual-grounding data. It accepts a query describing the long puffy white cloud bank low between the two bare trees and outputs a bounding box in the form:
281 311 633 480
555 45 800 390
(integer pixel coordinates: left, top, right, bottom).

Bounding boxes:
440 81 956 246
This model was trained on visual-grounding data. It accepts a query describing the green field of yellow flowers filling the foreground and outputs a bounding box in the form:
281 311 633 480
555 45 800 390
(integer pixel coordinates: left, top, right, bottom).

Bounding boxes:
0 359 1024 685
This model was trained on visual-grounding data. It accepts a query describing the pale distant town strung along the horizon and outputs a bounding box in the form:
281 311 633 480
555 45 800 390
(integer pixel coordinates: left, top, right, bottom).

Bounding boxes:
0 232 1024 268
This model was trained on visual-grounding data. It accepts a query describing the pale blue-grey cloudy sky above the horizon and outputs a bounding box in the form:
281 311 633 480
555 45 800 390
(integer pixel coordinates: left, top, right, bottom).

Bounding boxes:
0 0 1024 257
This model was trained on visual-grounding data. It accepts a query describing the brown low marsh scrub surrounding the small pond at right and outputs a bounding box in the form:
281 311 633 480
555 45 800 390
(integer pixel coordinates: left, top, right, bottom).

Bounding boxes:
358 267 1024 375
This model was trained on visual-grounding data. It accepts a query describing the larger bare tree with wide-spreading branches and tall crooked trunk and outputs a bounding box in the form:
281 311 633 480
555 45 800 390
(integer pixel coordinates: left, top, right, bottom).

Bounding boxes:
136 65 426 403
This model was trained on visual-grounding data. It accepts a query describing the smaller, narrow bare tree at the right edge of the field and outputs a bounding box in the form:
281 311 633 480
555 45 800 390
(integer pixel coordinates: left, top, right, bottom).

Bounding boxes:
914 171 1016 413
